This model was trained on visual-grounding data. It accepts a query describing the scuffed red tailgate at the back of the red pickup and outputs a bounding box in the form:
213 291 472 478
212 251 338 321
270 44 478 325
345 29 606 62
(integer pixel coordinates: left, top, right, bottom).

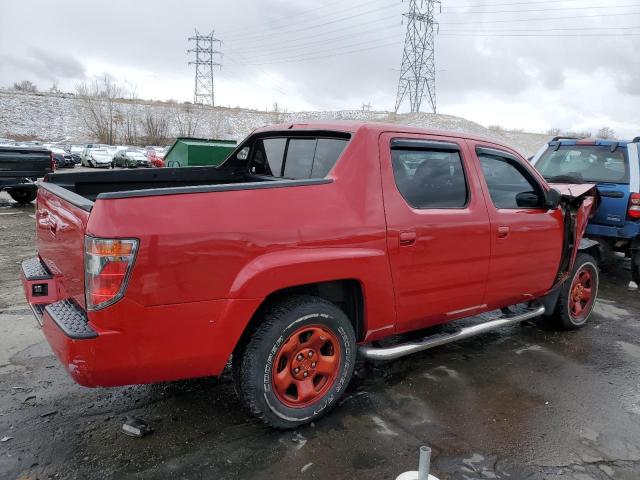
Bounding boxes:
36 184 89 308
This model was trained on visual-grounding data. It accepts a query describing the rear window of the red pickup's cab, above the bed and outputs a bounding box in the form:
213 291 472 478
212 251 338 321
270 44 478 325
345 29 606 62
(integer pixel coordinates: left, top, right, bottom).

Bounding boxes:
250 137 348 180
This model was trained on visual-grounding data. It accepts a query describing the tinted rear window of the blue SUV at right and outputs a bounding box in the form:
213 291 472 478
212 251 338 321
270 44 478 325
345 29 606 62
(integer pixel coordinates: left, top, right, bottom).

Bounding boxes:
536 145 629 183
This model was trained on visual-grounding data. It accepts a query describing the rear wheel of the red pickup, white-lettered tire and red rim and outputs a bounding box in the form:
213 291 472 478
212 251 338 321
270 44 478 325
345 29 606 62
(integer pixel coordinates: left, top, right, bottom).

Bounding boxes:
233 295 356 429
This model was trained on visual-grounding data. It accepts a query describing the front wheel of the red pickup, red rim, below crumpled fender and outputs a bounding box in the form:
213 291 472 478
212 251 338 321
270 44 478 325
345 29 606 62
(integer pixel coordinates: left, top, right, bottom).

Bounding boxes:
549 253 599 330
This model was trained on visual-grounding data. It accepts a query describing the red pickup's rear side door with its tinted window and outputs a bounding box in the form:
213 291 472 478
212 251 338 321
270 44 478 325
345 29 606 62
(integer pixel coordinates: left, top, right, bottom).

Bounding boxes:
379 133 490 331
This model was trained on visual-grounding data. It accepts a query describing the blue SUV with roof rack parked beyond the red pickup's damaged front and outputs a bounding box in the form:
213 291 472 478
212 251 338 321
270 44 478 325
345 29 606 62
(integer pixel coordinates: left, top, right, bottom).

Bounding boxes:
531 137 640 284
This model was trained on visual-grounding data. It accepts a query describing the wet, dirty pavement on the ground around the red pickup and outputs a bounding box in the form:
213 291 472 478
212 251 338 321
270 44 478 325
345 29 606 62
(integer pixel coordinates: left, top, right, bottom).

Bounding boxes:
0 194 640 480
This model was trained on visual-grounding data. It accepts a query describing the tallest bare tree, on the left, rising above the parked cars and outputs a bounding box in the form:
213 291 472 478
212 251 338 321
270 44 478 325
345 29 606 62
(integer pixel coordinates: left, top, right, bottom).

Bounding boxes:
76 74 123 144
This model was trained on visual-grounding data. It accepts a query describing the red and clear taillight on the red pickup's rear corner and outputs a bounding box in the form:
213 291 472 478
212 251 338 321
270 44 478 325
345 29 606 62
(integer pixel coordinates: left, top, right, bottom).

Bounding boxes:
84 237 138 310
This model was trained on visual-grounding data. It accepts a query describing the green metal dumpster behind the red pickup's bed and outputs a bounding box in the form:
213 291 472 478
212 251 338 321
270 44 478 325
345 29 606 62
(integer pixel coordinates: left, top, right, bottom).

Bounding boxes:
164 137 236 167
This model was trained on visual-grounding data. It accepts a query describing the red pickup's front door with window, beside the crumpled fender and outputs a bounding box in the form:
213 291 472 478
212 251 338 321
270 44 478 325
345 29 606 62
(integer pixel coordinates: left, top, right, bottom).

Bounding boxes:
469 141 564 308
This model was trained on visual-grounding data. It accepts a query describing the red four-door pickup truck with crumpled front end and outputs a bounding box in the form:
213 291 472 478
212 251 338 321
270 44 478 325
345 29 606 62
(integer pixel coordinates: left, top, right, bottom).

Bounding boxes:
23 122 598 428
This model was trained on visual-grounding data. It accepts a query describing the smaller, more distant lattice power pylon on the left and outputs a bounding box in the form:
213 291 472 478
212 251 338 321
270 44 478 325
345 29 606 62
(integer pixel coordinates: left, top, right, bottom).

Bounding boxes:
187 30 222 106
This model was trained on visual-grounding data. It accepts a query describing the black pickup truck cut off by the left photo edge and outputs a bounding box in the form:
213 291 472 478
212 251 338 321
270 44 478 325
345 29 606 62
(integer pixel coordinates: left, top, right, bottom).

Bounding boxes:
0 146 55 204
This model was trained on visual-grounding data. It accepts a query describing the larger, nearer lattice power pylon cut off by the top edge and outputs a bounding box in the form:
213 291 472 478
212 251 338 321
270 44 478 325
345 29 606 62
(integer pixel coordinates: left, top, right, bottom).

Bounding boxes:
395 0 440 113
